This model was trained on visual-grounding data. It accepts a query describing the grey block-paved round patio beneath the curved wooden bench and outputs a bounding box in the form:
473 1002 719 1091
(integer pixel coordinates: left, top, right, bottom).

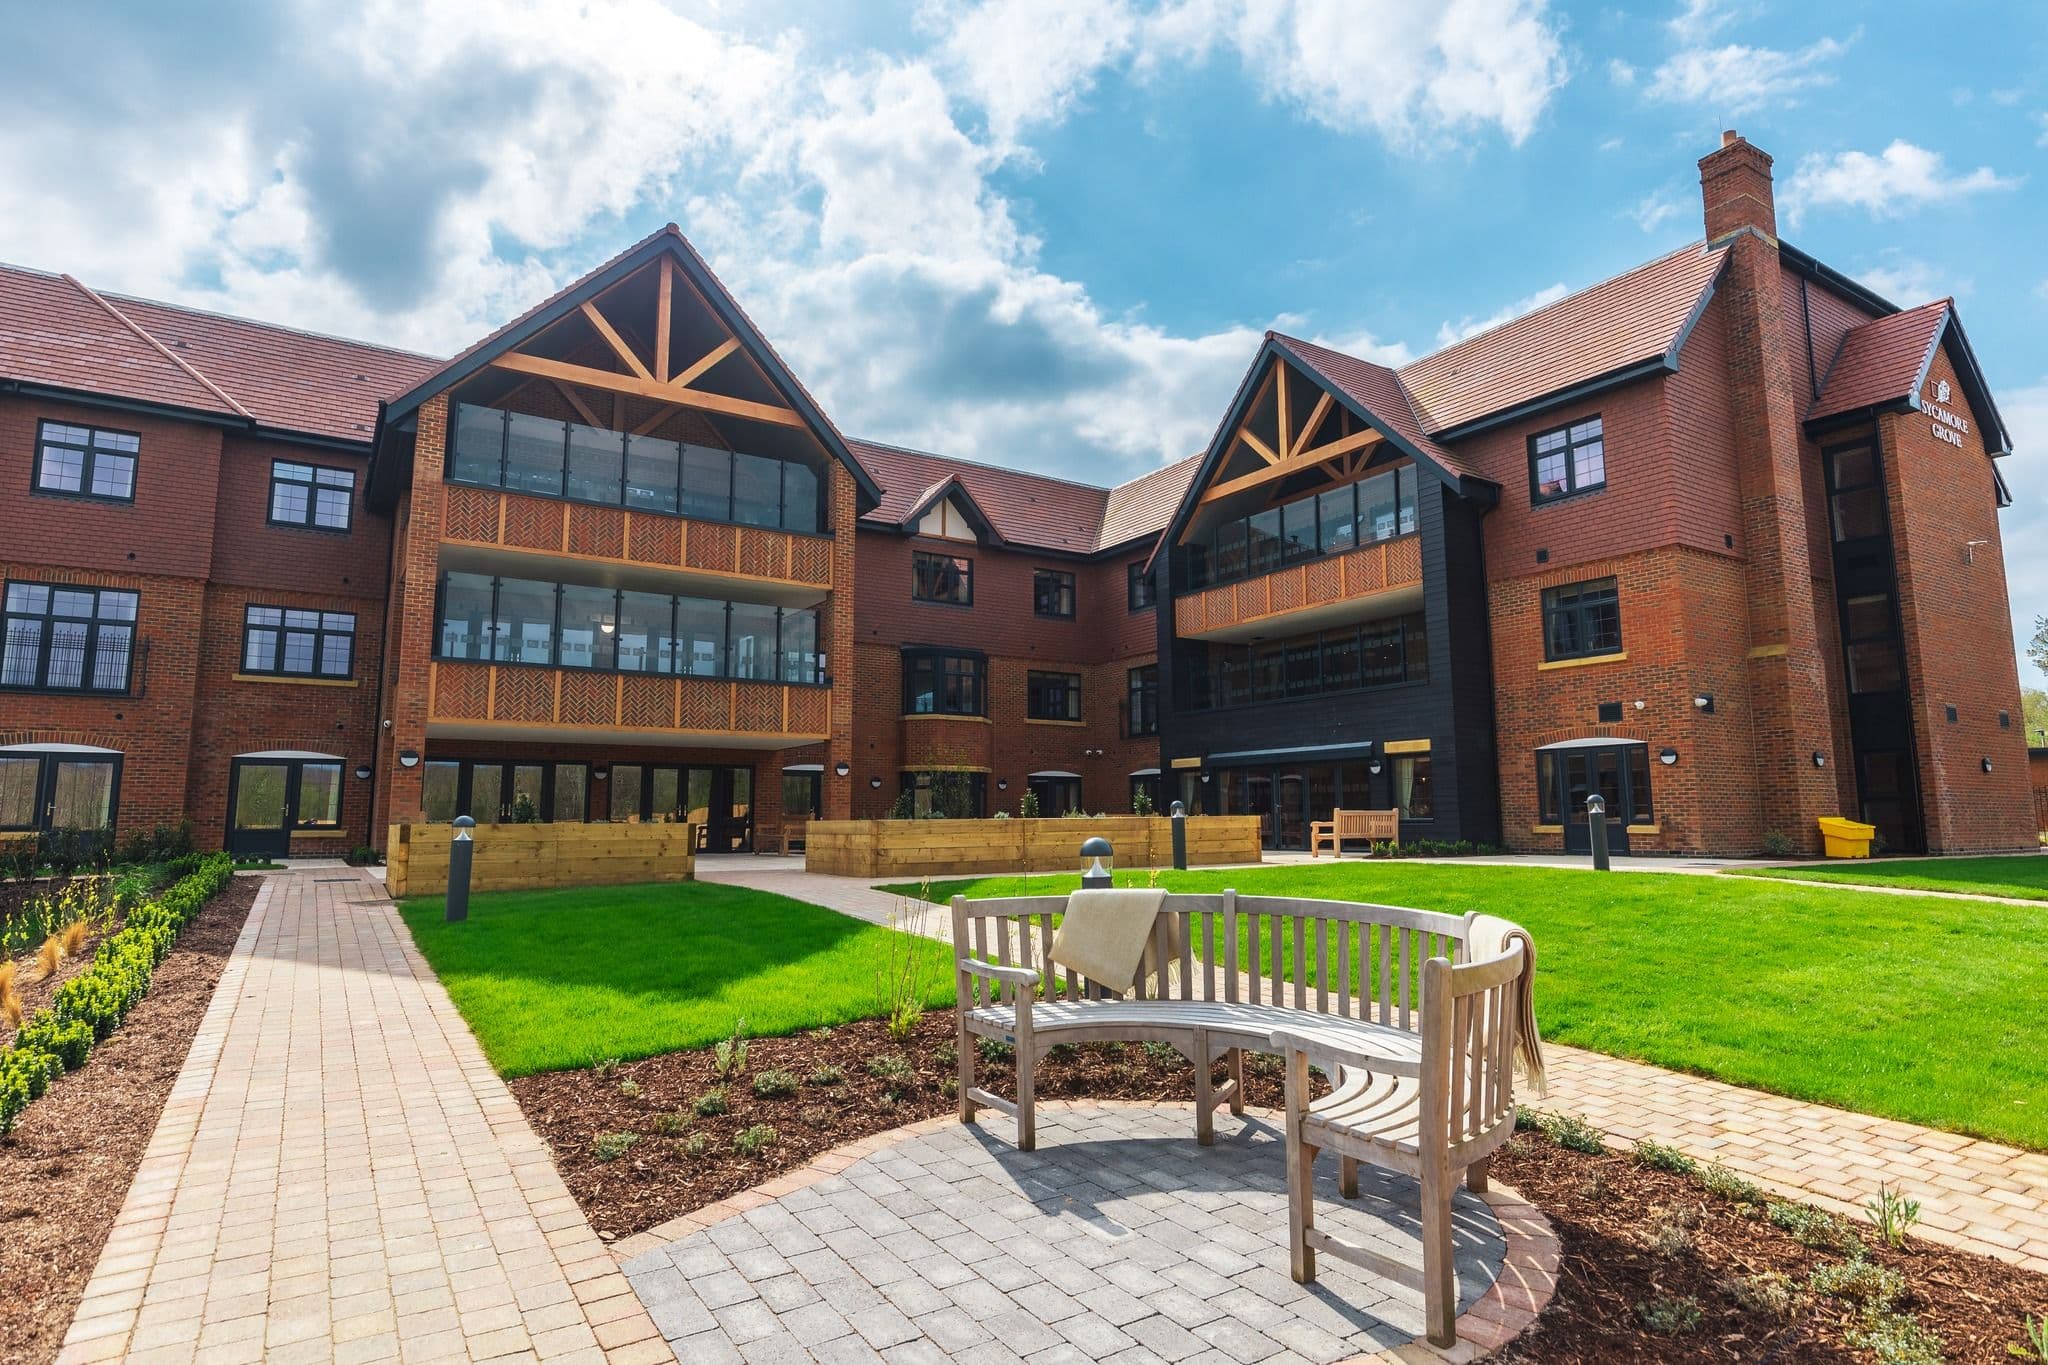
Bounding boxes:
625 1103 1507 1365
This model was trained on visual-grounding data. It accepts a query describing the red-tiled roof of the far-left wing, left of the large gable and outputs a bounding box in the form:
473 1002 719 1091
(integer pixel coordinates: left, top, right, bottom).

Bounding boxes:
0 266 434 444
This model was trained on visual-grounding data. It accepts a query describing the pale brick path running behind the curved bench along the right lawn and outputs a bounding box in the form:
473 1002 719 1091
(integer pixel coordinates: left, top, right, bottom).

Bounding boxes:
705 871 2048 1271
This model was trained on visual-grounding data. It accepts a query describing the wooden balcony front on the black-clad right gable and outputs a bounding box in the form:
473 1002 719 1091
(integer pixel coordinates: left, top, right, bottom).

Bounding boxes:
1174 536 1421 641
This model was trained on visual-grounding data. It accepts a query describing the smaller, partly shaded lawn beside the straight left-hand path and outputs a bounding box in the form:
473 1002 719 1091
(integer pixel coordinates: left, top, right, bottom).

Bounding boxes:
401 882 952 1076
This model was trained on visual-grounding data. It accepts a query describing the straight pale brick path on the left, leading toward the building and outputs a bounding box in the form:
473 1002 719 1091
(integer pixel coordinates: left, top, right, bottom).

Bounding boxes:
59 868 670 1363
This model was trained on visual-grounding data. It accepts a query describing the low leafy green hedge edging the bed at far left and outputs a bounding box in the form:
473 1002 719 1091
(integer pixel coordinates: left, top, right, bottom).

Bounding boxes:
0 853 236 1136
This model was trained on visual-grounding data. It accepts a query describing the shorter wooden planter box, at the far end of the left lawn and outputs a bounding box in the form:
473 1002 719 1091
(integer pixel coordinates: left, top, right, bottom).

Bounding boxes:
385 825 696 896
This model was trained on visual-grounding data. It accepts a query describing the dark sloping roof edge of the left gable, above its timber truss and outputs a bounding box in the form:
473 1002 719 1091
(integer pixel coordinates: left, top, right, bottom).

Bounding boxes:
381 223 881 505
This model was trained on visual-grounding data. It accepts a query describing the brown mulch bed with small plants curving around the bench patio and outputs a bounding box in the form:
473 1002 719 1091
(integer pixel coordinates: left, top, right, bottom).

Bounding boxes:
510 1011 2048 1365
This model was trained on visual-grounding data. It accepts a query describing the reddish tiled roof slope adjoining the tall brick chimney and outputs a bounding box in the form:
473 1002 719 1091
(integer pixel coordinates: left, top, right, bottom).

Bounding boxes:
1399 241 1726 436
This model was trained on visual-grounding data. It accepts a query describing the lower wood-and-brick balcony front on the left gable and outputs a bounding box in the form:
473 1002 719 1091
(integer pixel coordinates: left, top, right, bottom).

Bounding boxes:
426 659 831 749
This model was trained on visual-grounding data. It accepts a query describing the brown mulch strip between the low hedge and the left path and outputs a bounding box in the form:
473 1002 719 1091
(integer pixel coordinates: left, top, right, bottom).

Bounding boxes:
0 878 258 1363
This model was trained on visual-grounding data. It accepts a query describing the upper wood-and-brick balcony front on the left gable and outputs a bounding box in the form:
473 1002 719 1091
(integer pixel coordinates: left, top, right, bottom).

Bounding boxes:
440 483 831 606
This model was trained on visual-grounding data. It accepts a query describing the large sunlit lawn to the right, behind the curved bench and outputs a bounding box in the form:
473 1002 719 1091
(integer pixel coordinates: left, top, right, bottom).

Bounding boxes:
899 862 2048 1150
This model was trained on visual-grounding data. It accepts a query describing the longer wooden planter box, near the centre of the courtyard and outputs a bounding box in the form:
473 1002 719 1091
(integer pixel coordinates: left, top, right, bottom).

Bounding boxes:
803 814 1260 878
